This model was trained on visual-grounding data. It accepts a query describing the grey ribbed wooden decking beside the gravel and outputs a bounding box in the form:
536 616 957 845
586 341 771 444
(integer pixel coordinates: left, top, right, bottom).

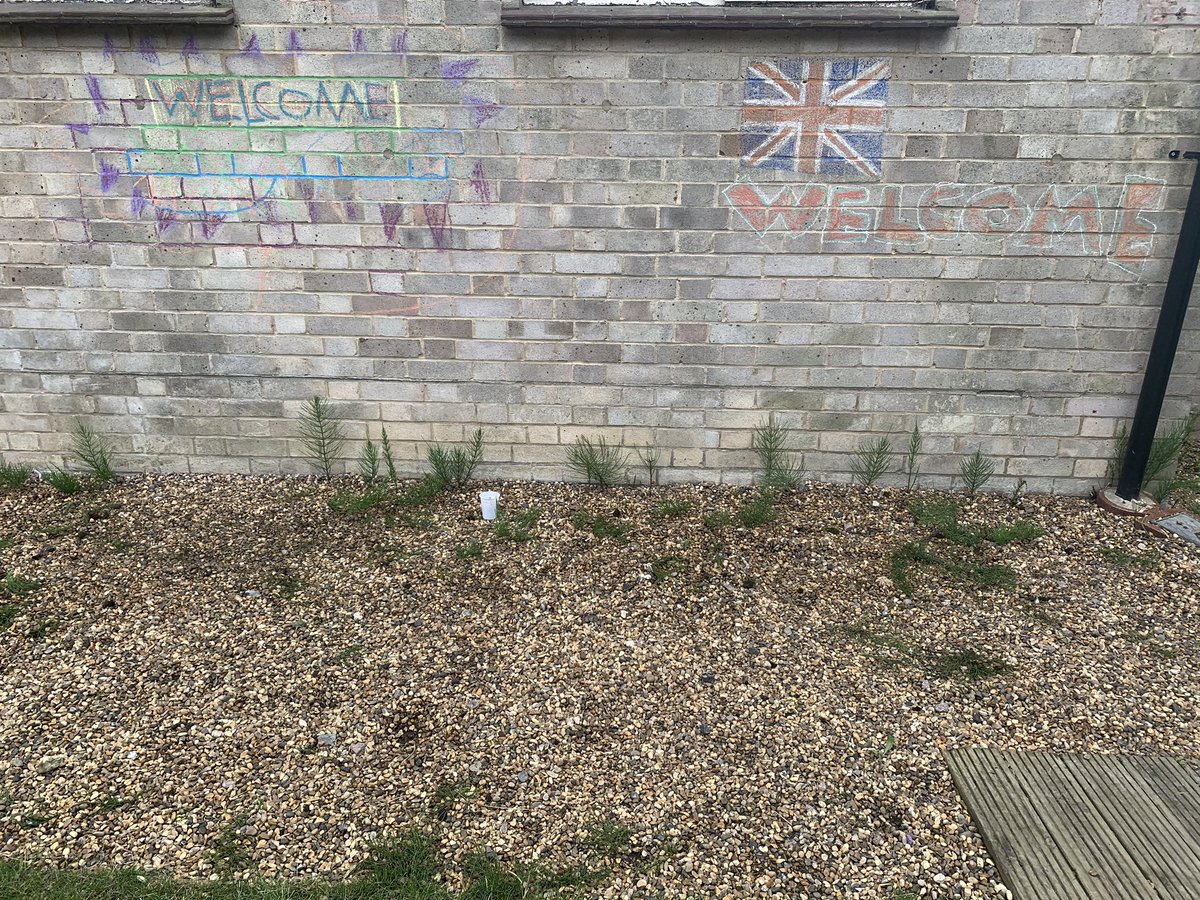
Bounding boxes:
946 749 1200 900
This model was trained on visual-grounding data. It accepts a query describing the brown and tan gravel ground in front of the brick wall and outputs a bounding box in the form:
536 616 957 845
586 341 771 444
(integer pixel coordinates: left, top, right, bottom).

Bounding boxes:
0 476 1200 900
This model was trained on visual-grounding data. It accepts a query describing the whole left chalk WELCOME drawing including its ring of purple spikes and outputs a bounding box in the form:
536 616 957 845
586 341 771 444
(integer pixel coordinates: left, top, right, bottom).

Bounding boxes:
72 28 505 248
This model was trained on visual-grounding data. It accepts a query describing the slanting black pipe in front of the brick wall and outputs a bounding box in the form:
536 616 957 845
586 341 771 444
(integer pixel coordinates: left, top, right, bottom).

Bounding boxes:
1117 150 1200 502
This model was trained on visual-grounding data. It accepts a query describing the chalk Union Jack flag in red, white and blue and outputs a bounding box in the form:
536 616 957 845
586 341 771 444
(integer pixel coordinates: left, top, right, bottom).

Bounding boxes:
742 58 890 181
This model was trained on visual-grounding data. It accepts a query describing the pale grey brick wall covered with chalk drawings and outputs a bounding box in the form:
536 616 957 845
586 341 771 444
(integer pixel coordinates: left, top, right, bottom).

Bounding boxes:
0 0 1200 492
